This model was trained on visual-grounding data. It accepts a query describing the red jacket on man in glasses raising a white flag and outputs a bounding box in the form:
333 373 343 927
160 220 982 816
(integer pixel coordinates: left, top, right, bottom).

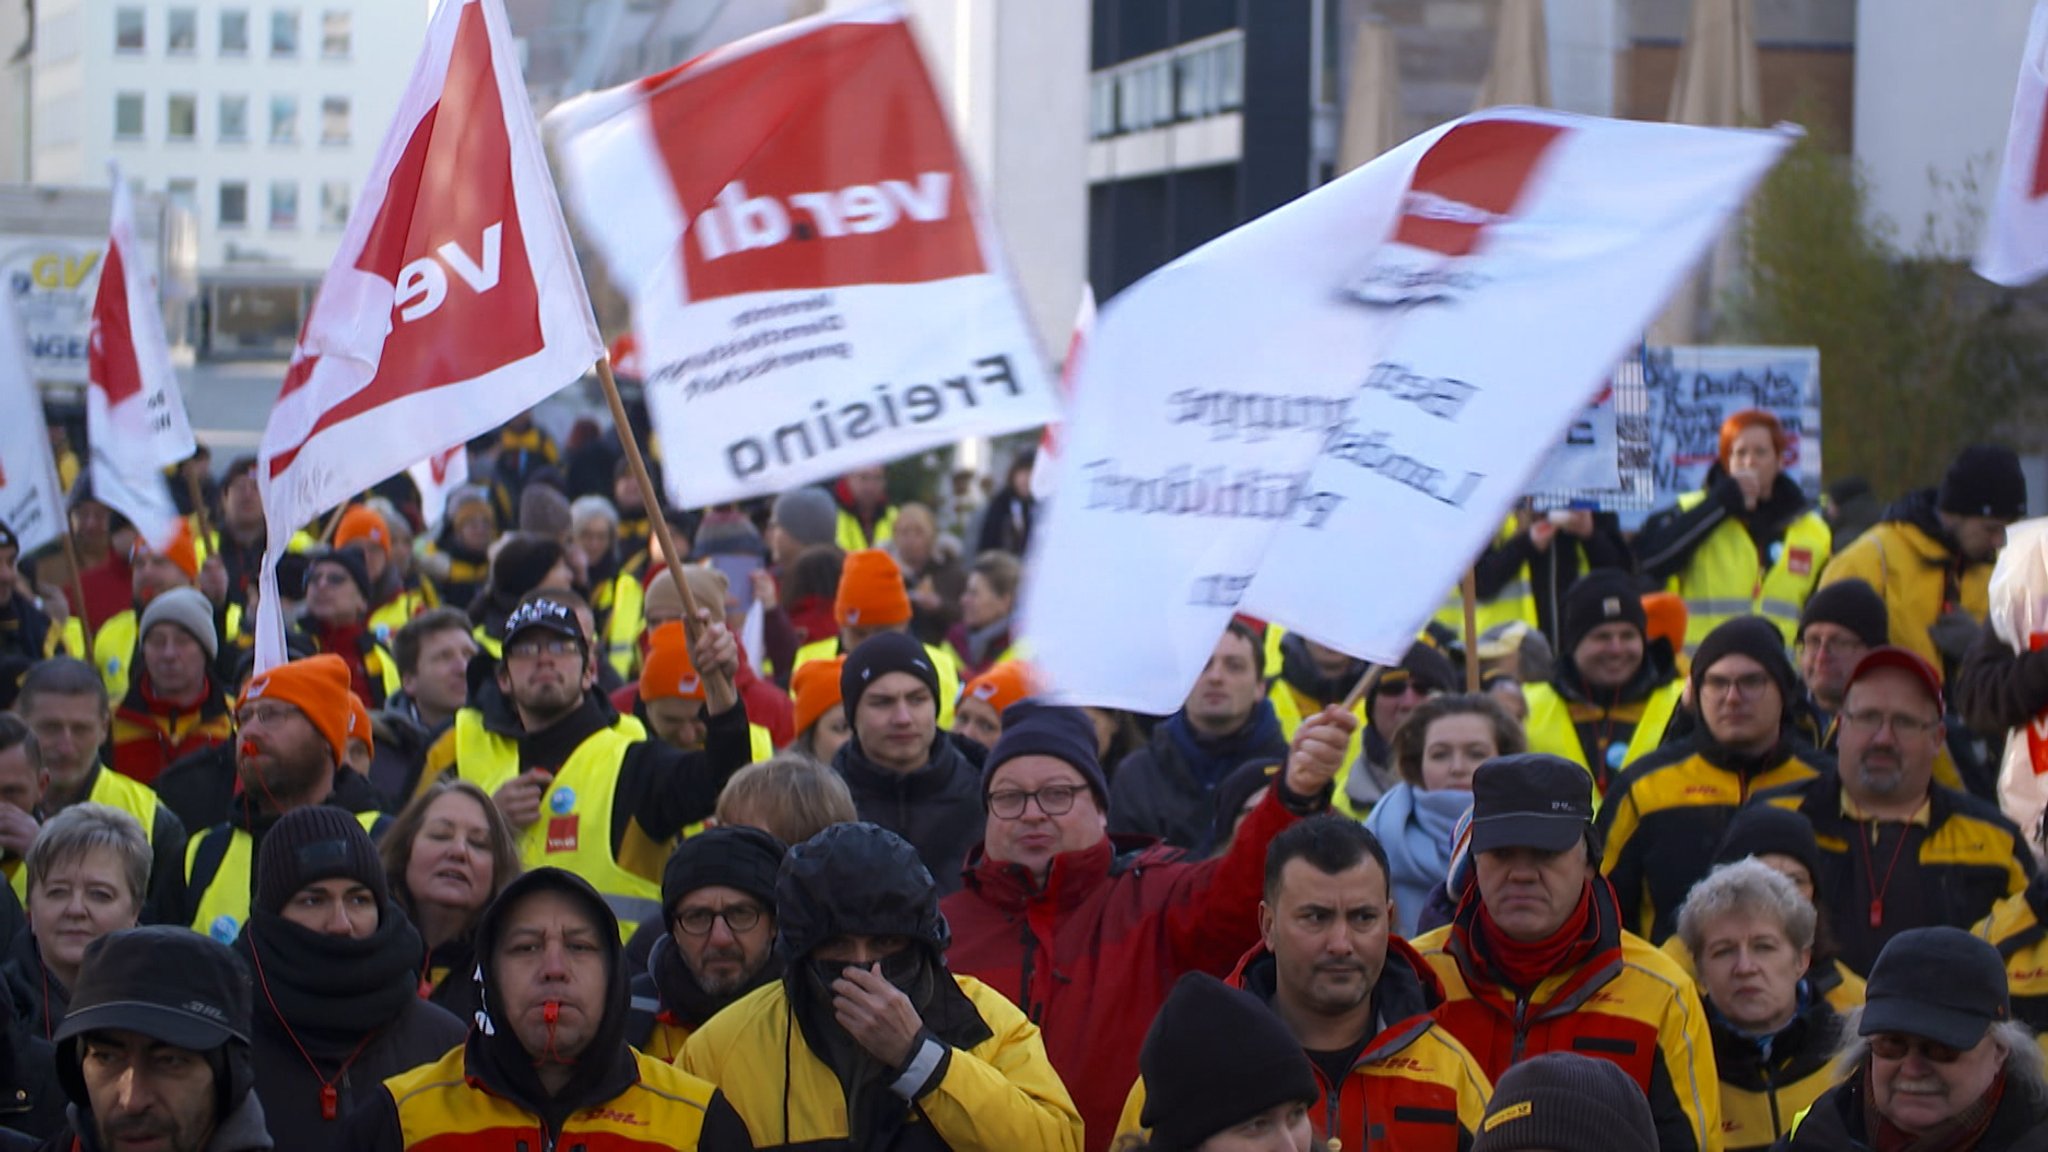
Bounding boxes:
940 774 1298 1152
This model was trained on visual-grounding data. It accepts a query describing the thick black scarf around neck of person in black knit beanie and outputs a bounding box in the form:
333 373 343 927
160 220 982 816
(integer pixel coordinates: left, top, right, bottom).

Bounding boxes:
236 900 426 1060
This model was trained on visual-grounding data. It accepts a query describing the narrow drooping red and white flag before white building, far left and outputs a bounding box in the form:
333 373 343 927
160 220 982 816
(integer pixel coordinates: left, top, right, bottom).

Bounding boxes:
86 164 195 549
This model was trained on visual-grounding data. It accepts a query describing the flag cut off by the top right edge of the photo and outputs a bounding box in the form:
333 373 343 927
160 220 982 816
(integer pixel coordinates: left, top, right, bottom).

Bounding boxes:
1976 0 2048 287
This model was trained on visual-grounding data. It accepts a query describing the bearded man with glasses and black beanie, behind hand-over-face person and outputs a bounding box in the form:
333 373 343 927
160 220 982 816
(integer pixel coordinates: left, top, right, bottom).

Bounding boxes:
627 824 784 1064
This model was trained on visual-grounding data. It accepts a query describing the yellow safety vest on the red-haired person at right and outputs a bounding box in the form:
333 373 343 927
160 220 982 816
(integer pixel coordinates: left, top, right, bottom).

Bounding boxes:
1669 492 1835 658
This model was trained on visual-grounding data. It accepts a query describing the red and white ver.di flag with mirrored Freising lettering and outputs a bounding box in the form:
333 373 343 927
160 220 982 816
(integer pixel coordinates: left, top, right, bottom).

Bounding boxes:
547 4 1057 508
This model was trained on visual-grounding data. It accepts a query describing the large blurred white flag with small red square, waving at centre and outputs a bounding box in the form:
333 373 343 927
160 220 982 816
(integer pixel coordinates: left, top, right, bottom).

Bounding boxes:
1022 109 1788 713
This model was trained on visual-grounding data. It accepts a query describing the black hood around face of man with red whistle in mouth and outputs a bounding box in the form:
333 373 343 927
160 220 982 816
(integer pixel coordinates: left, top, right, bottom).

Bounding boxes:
465 867 639 1132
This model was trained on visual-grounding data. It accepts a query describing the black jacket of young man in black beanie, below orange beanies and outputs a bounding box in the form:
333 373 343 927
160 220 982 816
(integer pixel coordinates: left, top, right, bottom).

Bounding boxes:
831 732 989 896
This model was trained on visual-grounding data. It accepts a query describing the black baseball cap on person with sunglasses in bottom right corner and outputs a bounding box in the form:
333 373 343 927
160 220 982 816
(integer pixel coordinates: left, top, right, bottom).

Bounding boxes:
1855 927 2013 1052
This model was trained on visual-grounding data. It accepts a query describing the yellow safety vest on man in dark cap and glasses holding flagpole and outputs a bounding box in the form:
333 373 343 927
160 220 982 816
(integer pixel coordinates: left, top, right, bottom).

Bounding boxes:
455 707 662 937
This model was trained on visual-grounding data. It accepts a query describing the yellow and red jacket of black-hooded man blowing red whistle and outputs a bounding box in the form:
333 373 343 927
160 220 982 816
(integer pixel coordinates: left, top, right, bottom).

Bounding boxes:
376 1047 715 1152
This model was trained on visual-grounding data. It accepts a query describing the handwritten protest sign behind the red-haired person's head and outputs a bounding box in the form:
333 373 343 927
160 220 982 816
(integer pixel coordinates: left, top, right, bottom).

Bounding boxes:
1642 346 1821 502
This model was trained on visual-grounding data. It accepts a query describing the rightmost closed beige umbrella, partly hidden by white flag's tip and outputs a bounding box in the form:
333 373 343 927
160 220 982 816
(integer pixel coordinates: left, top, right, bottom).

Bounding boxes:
1651 0 1763 344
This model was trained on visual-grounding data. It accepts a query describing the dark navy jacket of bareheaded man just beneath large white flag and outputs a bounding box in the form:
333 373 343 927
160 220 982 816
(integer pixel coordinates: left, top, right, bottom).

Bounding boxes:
1114 699 1286 853
